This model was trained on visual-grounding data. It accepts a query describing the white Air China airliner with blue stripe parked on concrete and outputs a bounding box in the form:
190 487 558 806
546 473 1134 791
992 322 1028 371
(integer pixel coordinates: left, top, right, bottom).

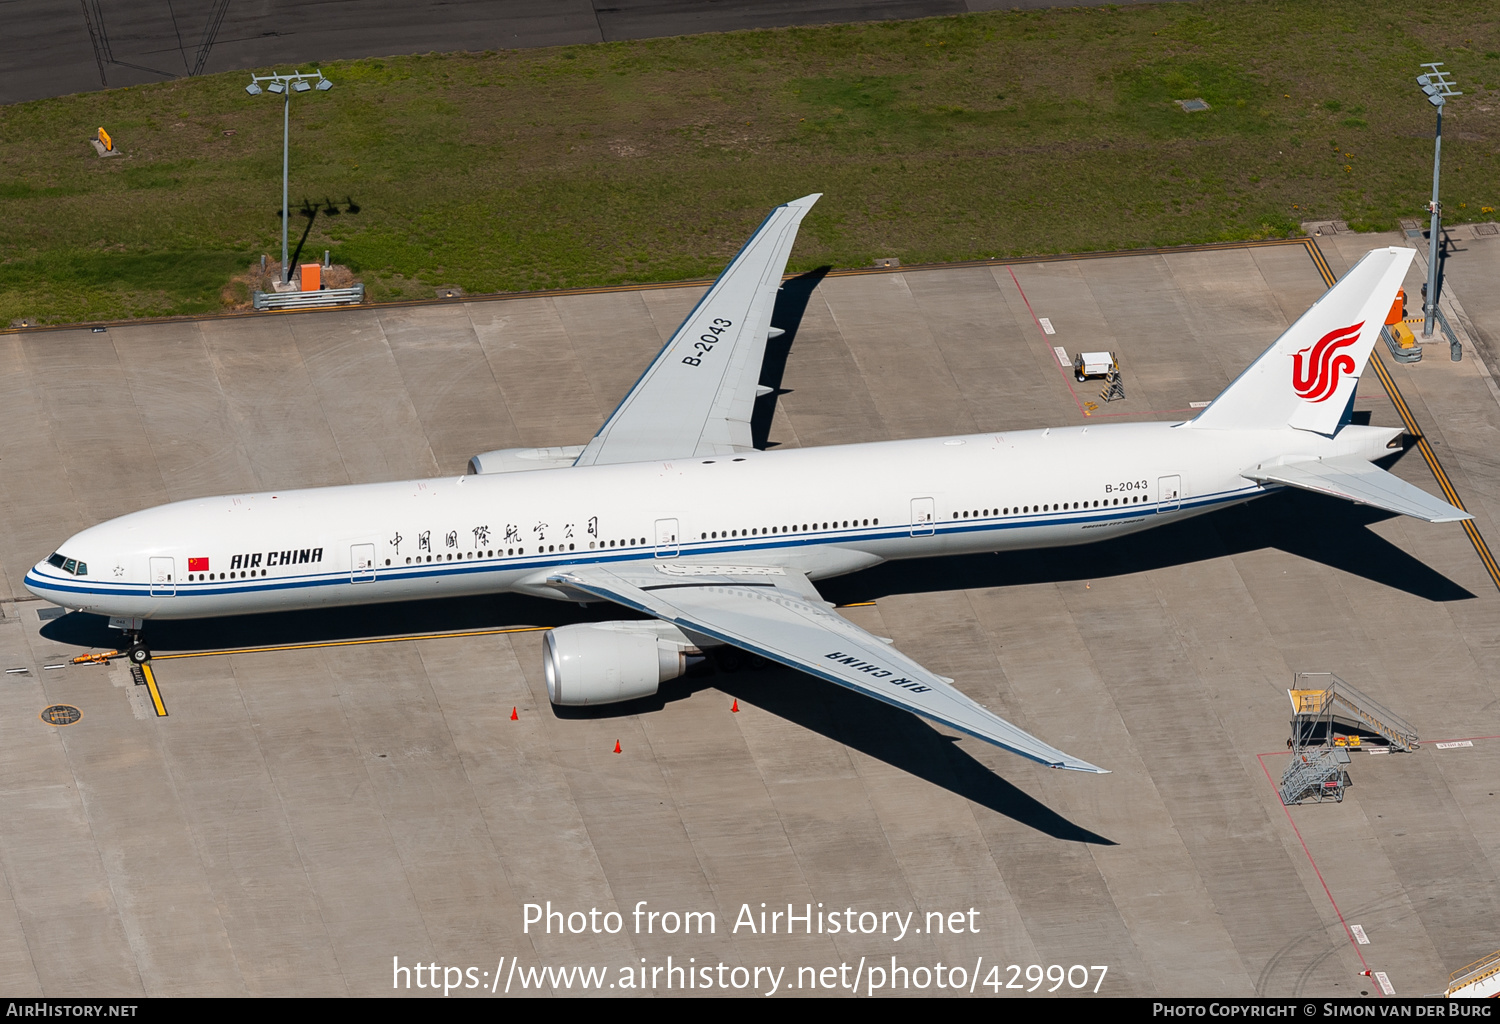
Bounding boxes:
26 195 1469 772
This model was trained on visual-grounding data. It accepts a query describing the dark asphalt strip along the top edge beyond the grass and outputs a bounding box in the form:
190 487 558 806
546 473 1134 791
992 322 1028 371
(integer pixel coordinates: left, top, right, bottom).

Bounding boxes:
0 0 1170 103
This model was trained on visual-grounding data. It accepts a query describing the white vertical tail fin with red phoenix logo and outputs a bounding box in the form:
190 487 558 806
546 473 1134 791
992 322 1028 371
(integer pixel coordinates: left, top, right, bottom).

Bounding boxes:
1185 246 1416 433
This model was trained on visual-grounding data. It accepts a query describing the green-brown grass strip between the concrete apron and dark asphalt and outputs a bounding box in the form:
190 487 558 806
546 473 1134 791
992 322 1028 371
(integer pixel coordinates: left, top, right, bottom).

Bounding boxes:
0 0 1500 327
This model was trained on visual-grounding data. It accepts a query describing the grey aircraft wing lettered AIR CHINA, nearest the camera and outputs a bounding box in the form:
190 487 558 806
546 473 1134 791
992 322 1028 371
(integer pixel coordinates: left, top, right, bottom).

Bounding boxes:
548 561 1106 774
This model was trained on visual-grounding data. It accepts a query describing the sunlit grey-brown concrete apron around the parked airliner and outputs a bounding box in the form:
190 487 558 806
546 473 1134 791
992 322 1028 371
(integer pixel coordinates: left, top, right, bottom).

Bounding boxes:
0 237 1500 996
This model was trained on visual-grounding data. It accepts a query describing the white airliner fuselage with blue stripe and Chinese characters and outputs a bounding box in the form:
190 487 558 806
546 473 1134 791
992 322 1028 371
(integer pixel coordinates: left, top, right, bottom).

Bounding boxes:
26 423 1398 619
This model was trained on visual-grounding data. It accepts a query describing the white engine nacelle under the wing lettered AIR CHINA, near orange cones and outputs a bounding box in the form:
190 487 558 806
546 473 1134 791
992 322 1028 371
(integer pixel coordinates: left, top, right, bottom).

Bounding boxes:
542 622 701 706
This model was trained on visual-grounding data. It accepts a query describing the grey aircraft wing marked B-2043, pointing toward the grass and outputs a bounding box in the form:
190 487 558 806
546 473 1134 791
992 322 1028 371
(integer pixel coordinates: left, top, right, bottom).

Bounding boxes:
573 192 822 466
